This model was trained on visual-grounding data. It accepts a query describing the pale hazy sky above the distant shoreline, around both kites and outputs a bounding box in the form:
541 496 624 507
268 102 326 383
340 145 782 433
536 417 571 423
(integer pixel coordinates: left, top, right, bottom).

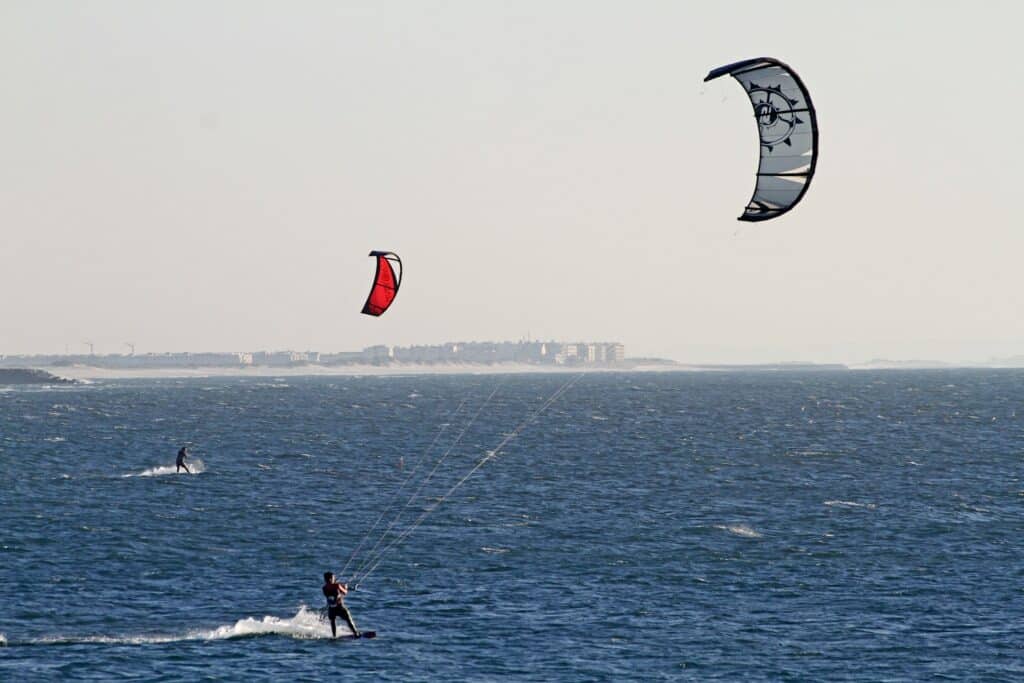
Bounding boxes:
0 0 1024 361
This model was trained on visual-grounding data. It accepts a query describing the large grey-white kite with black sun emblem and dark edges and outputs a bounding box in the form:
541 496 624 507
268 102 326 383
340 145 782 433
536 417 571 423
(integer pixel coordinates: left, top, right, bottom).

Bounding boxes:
705 57 818 221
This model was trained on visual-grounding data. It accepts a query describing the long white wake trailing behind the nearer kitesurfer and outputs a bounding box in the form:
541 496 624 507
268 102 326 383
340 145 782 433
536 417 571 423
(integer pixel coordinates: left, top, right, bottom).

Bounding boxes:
14 605 333 645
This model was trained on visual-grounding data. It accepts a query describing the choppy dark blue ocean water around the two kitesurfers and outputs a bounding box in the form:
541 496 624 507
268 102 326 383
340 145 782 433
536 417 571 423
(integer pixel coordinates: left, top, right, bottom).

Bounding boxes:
0 371 1024 681
